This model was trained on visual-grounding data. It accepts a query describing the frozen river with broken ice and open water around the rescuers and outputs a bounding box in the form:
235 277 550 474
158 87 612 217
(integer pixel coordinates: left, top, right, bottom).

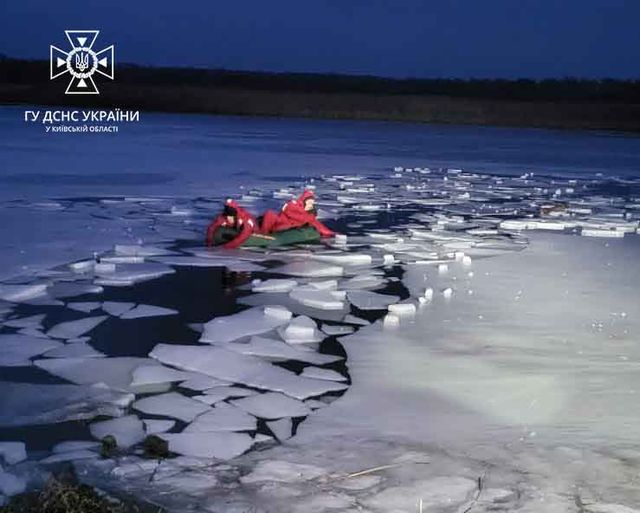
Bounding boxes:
0 108 640 513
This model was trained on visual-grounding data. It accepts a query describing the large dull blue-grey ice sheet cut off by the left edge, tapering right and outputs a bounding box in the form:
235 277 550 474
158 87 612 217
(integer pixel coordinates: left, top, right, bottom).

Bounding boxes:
0 381 134 426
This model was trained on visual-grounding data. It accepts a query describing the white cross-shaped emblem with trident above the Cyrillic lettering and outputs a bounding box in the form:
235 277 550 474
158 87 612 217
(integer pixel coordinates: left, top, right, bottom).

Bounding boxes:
49 30 114 94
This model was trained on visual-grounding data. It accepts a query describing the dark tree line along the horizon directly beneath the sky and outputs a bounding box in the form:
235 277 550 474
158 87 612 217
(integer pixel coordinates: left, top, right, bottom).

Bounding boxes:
0 55 640 104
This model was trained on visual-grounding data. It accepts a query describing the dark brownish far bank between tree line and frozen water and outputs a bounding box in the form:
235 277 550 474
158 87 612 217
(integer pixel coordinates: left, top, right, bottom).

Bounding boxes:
0 83 640 134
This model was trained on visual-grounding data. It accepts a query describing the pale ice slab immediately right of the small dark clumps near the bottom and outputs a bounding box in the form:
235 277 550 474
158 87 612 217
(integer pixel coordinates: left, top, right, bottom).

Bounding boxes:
159 432 254 460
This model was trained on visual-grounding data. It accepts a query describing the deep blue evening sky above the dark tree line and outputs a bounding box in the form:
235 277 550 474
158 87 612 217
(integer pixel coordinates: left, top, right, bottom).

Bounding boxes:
0 0 640 78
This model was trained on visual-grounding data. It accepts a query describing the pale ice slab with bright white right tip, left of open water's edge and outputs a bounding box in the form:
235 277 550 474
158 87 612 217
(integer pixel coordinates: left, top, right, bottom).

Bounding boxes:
200 307 291 344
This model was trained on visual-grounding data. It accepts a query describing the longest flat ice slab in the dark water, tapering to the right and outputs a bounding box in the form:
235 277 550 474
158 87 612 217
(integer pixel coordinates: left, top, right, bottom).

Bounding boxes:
150 344 347 399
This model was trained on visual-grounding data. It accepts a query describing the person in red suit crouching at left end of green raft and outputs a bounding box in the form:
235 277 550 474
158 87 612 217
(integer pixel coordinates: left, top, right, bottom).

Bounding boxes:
207 199 271 249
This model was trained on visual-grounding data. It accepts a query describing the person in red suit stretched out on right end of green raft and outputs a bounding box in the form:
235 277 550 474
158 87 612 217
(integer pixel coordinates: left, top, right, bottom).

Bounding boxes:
261 190 335 237
